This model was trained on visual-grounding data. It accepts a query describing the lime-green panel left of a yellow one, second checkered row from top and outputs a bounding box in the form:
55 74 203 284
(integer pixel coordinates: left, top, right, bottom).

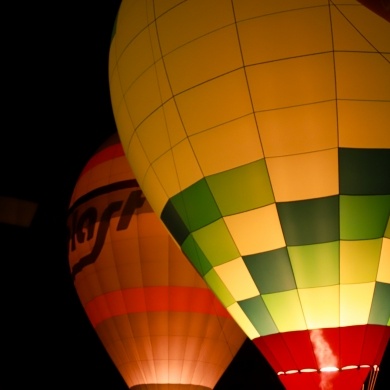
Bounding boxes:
193 219 240 267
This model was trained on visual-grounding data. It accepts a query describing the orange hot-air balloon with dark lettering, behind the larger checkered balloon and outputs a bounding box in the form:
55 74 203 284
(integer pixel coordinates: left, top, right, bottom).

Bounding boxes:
68 134 246 390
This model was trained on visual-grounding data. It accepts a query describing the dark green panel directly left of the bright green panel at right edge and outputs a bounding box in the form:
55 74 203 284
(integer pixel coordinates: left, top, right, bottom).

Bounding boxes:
276 196 340 246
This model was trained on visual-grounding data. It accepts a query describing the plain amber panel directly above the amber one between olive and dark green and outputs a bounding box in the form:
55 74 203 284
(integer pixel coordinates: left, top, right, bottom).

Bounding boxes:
256 101 338 157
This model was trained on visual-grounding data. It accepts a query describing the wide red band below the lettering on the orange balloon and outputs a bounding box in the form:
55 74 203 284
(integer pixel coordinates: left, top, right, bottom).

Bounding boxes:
85 286 231 327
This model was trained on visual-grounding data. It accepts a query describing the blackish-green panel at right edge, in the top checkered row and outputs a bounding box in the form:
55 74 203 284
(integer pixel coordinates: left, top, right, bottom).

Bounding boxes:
339 148 390 195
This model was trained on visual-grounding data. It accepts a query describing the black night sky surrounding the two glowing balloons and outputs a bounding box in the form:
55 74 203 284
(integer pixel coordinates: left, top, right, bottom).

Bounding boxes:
0 0 390 390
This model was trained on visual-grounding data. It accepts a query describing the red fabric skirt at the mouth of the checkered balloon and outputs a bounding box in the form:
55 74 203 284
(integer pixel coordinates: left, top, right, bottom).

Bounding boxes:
253 325 390 390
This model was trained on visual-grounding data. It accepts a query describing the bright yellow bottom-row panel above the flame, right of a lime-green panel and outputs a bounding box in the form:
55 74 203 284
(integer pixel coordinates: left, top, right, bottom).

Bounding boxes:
298 286 340 329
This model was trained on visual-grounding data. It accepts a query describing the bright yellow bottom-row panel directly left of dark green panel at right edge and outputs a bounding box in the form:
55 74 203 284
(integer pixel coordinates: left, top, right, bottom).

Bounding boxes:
340 282 375 326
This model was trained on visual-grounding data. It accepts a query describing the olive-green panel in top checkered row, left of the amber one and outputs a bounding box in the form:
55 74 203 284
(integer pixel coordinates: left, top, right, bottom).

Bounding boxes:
206 159 274 216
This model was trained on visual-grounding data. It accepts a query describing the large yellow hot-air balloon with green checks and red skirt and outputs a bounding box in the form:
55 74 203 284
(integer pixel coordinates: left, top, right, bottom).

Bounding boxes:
109 0 390 390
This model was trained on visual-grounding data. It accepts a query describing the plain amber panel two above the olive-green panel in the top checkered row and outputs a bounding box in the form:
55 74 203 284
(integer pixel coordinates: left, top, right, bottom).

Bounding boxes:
176 69 252 135
